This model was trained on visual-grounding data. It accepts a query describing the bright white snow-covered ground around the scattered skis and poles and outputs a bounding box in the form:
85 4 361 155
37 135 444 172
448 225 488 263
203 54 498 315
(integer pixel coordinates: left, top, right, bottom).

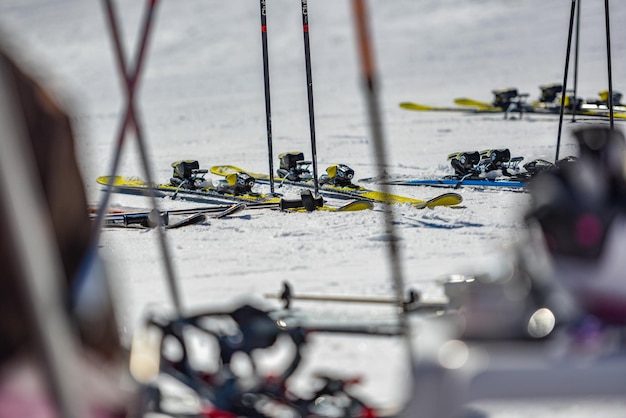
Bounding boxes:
0 0 626 418
